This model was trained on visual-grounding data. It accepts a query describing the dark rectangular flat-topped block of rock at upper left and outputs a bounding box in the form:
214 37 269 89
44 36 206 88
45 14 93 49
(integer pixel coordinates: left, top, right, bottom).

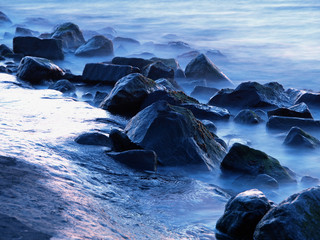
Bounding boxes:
13 37 64 59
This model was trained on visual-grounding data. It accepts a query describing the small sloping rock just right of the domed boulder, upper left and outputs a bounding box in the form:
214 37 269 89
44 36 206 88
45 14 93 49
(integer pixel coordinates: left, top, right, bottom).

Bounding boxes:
75 35 113 57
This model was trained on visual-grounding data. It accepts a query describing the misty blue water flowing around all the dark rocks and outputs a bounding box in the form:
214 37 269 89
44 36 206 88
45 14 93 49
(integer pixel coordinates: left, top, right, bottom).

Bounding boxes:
0 0 320 239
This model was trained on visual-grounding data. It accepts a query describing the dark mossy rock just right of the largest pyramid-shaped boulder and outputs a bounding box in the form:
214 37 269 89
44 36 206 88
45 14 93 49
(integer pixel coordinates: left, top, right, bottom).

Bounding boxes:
221 143 295 182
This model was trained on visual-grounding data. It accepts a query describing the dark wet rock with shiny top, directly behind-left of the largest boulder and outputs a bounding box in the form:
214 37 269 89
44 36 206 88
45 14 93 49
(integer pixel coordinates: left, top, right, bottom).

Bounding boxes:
100 73 159 116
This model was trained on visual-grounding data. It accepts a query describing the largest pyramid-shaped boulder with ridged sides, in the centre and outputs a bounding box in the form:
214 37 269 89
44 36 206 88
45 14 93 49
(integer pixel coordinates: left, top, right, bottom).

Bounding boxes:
125 101 225 170
